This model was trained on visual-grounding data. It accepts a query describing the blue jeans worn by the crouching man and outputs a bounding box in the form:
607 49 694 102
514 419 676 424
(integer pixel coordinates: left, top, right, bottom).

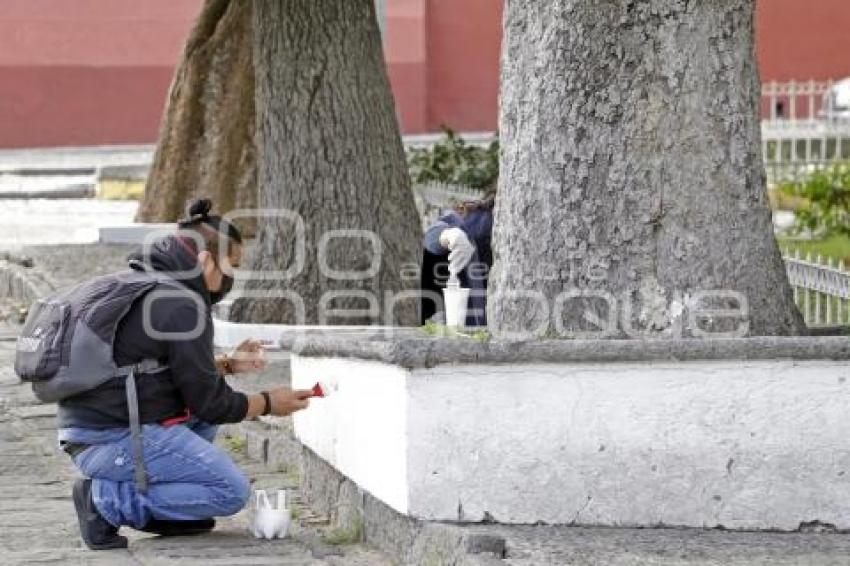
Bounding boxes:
69 419 251 528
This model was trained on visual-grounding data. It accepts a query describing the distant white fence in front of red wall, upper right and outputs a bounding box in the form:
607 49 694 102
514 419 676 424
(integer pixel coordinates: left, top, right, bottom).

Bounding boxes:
761 81 850 186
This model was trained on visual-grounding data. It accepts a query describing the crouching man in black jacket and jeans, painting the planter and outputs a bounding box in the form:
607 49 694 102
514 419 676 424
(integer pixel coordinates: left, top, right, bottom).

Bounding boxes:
58 200 310 549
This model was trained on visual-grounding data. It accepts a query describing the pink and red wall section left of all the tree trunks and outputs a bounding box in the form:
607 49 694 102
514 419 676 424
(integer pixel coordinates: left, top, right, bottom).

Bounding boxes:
0 0 202 148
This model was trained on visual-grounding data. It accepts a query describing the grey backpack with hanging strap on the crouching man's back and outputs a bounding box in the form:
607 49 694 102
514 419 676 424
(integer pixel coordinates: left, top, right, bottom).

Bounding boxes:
15 270 179 491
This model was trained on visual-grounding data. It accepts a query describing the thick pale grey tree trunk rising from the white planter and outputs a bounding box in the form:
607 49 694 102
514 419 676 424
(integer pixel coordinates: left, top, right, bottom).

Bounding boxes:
489 0 805 336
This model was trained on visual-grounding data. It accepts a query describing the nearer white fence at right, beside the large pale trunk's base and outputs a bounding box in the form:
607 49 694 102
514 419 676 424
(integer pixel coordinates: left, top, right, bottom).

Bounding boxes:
784 251 850 327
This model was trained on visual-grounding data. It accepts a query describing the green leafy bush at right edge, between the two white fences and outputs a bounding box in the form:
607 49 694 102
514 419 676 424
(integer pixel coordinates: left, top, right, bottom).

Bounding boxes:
780 163 850 237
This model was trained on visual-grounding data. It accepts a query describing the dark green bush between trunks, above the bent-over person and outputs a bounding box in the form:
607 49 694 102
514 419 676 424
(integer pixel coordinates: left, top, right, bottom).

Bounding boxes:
407 126 499 189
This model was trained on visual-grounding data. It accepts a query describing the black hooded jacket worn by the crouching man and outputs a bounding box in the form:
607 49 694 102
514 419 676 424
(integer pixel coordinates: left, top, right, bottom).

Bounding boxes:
58 236 248 429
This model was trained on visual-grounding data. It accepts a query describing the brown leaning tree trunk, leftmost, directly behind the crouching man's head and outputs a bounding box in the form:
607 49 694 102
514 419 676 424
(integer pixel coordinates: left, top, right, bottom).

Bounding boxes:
136 0 257 232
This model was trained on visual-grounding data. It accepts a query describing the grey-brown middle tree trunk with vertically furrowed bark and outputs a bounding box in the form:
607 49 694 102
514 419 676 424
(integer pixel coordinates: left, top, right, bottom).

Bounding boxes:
230 0 421 325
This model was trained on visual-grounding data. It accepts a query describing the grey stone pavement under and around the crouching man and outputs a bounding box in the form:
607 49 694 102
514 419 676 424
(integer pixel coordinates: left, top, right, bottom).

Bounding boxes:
0 326 391 566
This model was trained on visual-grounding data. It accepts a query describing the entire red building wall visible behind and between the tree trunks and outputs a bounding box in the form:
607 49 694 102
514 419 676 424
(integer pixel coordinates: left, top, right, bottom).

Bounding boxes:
0 0 850 148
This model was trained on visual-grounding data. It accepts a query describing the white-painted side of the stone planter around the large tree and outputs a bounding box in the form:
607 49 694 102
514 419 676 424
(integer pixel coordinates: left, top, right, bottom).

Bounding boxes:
292 354 850 530
